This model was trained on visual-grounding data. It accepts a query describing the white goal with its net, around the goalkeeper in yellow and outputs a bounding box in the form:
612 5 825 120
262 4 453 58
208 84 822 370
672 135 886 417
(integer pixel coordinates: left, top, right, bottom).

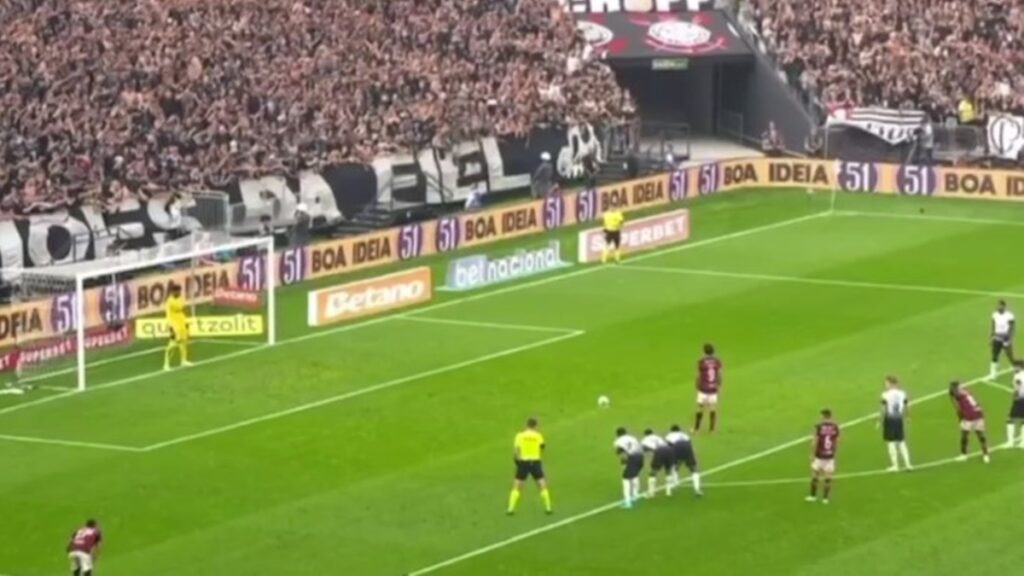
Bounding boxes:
0 232 275 394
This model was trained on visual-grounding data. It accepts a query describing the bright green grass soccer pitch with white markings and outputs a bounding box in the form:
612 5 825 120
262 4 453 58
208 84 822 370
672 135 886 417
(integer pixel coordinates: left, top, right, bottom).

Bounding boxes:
0 191 1024 576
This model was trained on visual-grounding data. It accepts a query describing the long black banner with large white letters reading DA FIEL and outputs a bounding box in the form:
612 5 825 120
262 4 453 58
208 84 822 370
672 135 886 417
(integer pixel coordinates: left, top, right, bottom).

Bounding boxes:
0 125 601 272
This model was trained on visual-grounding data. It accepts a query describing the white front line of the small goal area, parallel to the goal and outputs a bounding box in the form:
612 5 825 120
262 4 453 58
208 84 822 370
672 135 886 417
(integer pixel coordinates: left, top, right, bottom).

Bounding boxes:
140 331 584 452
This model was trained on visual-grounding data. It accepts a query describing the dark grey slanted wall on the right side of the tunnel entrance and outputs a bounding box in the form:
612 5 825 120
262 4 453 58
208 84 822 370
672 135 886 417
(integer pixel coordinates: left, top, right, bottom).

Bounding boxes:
718 50 814 151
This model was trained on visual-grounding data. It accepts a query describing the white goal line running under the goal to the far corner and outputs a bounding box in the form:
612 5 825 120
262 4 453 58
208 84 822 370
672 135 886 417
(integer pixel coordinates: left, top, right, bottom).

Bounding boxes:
0 211 829 416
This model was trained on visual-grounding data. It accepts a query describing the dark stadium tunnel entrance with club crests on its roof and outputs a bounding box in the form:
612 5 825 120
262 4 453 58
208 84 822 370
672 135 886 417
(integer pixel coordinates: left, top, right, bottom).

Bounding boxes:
593 10 814 158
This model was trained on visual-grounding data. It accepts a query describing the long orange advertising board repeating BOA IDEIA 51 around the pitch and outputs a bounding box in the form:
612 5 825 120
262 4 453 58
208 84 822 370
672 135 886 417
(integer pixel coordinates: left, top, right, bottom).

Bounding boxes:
6 154 1024 347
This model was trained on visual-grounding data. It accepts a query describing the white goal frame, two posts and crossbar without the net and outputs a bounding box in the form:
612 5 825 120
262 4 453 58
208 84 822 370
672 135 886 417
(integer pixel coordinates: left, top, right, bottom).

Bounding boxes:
75 236 276 390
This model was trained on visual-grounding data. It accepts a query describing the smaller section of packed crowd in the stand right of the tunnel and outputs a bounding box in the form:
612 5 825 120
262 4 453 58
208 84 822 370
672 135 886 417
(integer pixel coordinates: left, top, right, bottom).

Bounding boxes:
741 0 1024 120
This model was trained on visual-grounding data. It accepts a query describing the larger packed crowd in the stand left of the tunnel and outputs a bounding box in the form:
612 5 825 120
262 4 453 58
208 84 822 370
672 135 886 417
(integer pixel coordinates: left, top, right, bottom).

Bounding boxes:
0 0 631 212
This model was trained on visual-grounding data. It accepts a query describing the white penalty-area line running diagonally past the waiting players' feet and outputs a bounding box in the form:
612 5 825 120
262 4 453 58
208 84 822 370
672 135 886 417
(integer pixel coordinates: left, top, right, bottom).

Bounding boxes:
407 370 1009 576
